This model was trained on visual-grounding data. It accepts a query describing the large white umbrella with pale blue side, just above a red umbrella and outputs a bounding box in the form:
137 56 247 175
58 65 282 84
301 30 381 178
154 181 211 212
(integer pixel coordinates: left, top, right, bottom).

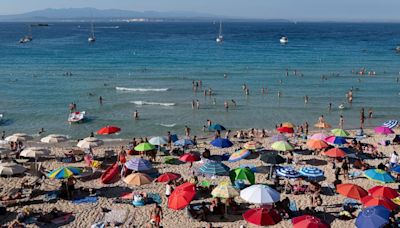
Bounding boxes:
240 184 281 204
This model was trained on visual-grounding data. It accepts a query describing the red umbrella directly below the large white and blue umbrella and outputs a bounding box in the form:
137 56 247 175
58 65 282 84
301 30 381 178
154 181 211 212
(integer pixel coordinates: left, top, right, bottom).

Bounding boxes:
243 207 282 226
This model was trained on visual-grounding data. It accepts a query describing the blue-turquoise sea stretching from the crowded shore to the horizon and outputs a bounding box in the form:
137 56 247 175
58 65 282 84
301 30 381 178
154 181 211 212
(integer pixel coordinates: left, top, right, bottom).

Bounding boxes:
0 22 400 138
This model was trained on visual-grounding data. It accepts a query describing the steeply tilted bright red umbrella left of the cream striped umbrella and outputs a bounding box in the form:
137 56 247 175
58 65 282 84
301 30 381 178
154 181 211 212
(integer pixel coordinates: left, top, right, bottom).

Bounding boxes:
168 182 196 210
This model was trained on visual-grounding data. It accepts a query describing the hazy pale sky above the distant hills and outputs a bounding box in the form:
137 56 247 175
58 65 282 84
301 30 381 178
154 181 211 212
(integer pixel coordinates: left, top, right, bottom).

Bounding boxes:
0 0 400 21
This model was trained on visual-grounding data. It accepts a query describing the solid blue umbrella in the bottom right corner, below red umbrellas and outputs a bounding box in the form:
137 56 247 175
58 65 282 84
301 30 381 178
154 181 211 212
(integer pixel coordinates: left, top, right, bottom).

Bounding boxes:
356 206 390 228
